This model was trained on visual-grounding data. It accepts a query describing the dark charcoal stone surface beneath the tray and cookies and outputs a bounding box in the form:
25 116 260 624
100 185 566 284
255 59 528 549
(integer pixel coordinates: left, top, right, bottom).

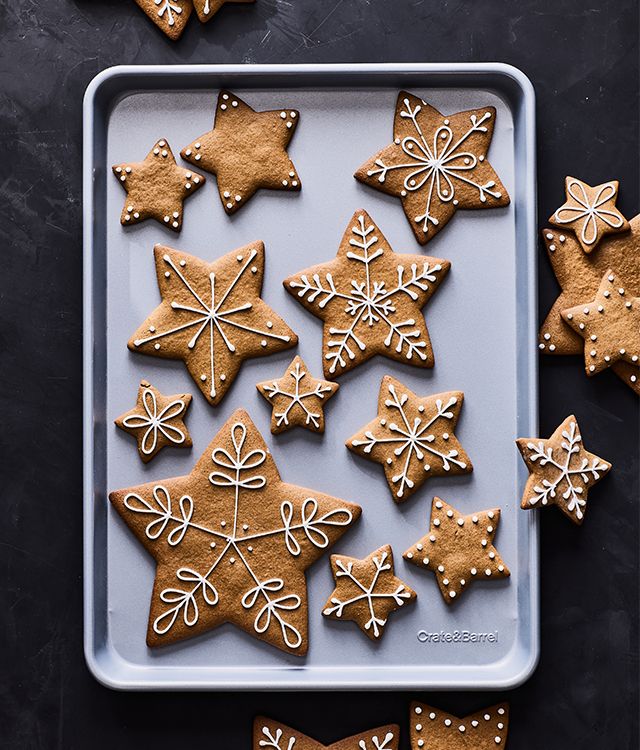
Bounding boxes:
0 0 640 750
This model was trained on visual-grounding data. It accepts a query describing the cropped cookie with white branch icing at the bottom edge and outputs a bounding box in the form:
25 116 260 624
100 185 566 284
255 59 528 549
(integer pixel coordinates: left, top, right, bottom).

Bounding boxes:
253 716 400 750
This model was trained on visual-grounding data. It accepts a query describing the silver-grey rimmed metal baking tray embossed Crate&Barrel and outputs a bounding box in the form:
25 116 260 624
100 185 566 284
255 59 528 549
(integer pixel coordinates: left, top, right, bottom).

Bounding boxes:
84 64 539 689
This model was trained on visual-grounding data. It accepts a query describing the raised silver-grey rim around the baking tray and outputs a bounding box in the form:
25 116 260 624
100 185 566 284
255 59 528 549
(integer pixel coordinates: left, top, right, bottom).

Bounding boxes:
82 62 540 691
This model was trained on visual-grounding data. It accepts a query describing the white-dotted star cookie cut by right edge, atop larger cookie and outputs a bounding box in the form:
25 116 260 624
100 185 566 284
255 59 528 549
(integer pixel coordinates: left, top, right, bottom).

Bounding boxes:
562 270 640 375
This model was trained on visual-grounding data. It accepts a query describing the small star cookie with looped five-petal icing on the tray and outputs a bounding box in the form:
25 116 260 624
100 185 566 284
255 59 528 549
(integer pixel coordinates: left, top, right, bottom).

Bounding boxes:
115 380 193 463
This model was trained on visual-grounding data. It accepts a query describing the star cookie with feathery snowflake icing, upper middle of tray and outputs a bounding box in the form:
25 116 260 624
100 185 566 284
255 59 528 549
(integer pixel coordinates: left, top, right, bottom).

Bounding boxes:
284 210 451 378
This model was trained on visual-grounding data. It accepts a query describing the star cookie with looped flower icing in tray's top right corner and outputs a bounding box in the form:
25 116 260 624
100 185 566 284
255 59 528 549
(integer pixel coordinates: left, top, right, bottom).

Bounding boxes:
354 91 509 245
